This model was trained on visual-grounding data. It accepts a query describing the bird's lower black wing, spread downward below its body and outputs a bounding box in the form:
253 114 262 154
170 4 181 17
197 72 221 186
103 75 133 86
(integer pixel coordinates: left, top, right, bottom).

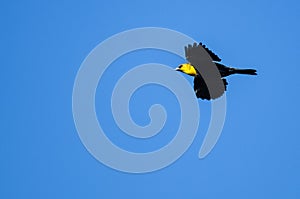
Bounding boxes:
194 75 228 100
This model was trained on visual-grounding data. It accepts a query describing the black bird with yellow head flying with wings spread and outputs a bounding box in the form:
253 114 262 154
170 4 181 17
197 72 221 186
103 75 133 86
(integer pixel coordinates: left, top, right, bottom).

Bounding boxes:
175 42 257 100
